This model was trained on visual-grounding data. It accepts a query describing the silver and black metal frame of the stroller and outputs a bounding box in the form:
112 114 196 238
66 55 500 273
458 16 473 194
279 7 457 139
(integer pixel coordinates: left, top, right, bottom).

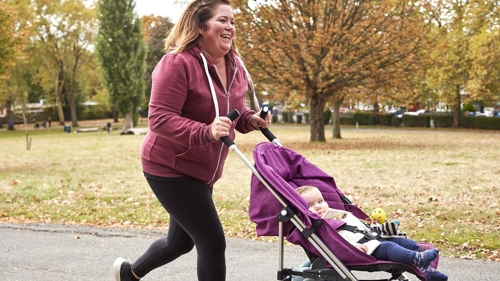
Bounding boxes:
221 111 418 281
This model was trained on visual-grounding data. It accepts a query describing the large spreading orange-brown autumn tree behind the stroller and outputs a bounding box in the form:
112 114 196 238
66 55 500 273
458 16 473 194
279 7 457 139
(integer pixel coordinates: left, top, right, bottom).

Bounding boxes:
236 0 434 141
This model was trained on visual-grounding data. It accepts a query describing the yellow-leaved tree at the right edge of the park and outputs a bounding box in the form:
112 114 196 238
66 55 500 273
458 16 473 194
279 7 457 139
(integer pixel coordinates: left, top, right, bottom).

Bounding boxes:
428 0 500 127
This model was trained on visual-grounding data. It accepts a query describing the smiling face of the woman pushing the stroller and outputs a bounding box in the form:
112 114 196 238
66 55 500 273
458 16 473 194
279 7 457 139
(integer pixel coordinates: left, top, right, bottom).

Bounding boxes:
198 4 235 59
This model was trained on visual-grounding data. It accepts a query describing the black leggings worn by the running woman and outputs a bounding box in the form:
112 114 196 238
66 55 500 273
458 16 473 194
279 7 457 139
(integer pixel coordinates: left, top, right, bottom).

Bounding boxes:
132 174 226 281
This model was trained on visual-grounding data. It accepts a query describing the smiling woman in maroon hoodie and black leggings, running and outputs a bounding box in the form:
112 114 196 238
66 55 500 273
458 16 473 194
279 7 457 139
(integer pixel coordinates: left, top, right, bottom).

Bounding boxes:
113 0 270 281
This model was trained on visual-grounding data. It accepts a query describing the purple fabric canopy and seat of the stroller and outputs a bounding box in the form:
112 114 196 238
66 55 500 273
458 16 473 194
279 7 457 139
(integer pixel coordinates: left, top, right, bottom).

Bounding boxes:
249 143 437 280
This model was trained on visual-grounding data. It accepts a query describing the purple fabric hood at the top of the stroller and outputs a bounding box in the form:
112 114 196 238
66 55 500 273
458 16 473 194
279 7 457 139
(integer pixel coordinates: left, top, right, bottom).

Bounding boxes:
250 143 367 236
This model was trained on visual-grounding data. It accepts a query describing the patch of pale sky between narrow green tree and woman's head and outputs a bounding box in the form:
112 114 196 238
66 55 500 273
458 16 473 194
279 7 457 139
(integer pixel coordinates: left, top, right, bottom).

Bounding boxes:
135 0 185 23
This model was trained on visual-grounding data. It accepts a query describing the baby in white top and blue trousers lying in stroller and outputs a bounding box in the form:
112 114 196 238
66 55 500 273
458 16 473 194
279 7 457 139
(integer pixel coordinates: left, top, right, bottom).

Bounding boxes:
296 185 448 281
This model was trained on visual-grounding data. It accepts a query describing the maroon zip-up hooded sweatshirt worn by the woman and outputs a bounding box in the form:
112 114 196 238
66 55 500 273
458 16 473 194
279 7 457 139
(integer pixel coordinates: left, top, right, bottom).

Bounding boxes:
141 46 255 186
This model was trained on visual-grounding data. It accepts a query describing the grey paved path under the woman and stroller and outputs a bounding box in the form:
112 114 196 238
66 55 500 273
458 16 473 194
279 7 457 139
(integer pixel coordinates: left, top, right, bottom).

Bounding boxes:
0 224 500 281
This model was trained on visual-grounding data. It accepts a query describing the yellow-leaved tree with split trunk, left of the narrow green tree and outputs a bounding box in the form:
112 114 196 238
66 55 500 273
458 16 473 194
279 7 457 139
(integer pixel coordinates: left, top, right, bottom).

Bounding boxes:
27 0 95 127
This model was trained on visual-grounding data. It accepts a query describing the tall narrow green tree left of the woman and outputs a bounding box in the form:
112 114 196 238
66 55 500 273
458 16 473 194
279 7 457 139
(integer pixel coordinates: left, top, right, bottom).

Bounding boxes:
96 0 146 133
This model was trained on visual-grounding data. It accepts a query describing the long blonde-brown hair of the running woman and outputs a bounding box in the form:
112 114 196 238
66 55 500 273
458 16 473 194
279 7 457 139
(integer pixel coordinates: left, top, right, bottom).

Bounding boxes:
164 0 240 56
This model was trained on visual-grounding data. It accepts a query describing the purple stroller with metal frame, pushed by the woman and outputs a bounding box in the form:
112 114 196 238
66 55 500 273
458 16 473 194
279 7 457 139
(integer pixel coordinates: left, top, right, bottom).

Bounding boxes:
223 109 439 281
